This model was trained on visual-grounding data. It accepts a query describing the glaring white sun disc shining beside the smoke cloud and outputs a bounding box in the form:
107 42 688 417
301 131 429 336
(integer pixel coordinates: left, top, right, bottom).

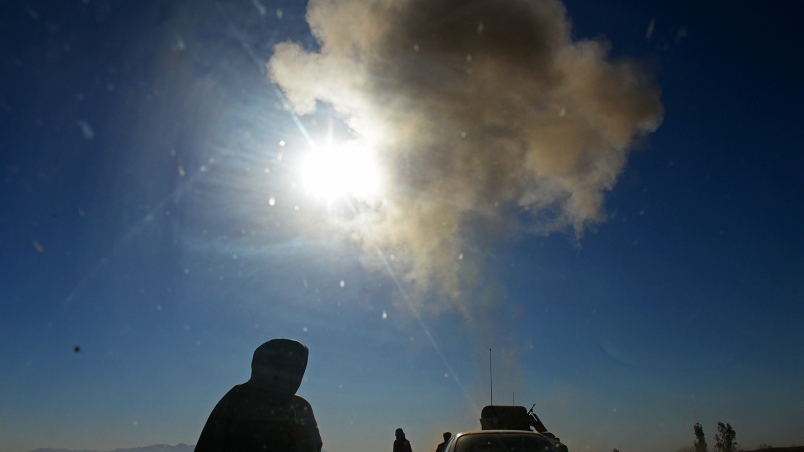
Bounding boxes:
301 139 381 201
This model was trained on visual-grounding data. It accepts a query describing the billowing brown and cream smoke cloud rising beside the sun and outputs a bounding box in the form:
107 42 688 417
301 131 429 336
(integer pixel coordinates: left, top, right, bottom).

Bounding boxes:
268 0 662 309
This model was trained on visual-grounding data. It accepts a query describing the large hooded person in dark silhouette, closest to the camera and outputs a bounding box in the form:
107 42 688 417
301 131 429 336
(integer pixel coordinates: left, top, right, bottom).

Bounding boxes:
195 339 322 452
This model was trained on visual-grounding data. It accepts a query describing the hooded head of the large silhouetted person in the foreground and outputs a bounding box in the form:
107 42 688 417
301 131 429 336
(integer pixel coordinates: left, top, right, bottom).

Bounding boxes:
249 339 309 395
